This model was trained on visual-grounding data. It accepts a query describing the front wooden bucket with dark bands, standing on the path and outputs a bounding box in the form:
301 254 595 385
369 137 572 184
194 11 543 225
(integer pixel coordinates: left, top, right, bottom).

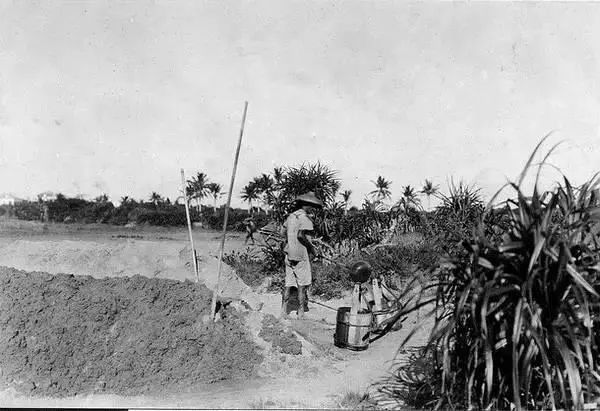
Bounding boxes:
333 307 373 351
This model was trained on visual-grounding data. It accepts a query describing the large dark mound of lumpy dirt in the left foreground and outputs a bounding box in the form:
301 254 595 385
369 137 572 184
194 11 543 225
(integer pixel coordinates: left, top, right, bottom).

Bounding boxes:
0 268 262 396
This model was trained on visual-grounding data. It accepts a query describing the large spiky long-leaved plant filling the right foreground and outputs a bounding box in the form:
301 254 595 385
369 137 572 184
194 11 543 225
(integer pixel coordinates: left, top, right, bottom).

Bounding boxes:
380 138 600 409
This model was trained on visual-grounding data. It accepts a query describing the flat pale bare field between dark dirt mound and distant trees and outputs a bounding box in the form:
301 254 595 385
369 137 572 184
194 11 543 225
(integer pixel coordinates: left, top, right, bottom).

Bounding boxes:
0 219 252 280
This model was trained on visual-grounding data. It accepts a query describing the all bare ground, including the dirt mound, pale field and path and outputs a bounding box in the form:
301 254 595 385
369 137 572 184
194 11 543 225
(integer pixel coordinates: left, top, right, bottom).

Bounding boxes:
0 221 430 408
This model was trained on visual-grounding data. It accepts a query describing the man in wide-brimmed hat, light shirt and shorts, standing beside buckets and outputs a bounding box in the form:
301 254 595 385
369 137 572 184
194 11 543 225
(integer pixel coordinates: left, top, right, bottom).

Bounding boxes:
281 191 323 319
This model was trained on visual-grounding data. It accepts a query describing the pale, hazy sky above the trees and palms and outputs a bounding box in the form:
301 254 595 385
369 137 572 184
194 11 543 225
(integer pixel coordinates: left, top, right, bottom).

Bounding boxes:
0 0 600 209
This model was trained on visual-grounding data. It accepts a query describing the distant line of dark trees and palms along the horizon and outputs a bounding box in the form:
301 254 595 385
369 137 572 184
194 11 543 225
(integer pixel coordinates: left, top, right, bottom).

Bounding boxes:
0 162 446 238
